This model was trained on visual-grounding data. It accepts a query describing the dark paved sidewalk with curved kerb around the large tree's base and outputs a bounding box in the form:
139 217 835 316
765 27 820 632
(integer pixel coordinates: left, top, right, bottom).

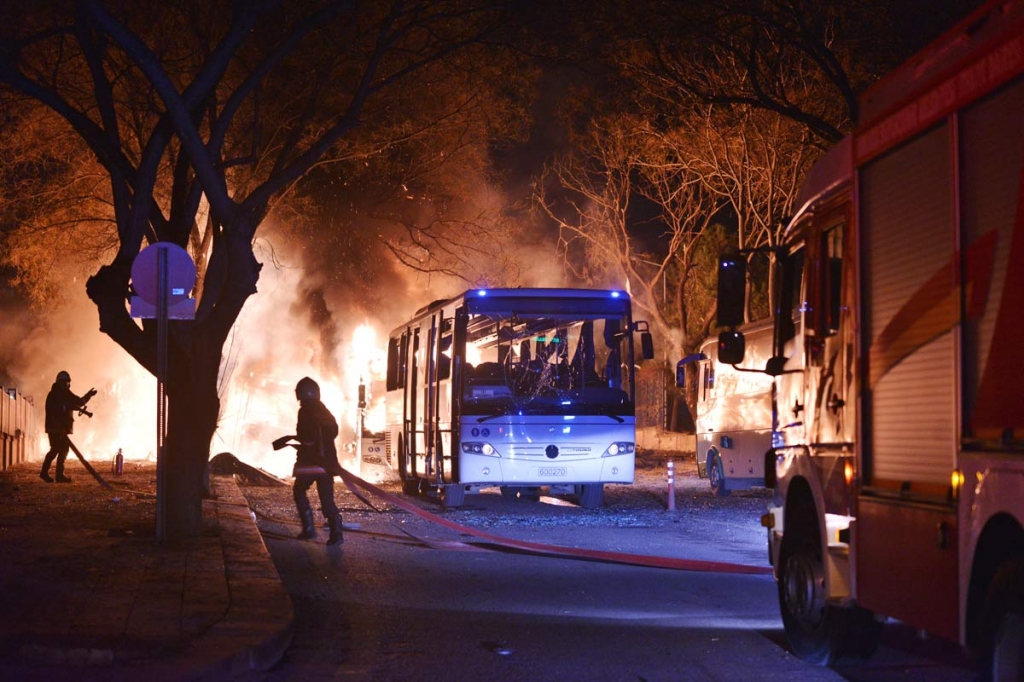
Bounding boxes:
0 457 294 682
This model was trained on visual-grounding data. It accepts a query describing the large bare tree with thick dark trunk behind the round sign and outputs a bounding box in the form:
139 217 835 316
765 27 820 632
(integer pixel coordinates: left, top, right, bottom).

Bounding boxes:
0 0 520 539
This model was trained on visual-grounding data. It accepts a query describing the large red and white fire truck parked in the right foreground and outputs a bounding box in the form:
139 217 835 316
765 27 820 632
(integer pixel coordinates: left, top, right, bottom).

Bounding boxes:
718 0 1024 667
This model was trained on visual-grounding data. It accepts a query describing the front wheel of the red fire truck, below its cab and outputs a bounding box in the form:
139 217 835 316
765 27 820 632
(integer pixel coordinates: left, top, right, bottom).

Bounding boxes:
778 539 882 666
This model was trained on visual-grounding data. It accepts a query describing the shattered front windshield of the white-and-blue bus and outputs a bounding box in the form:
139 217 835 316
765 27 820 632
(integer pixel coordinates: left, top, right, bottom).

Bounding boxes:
462 310 634 419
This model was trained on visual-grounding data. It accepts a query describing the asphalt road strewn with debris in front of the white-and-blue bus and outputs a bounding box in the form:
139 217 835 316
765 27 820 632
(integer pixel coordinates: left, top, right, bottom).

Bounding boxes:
237 466 975 682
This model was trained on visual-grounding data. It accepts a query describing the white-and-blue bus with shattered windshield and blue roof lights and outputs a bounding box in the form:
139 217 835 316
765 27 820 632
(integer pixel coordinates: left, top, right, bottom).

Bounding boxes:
385 289 653 508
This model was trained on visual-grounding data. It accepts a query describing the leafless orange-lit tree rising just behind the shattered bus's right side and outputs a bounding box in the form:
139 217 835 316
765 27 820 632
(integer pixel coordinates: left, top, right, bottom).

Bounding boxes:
538 116 719 356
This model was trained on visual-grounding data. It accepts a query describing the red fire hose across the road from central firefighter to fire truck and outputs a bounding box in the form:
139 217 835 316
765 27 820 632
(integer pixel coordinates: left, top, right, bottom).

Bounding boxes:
331 469 772 574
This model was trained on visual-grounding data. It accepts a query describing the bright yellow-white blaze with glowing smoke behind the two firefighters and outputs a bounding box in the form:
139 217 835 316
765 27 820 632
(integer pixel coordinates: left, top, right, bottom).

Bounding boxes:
20 241 391 477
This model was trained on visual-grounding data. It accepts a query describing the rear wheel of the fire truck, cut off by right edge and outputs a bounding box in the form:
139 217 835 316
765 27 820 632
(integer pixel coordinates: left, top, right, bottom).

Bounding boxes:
983 559 1024 682
